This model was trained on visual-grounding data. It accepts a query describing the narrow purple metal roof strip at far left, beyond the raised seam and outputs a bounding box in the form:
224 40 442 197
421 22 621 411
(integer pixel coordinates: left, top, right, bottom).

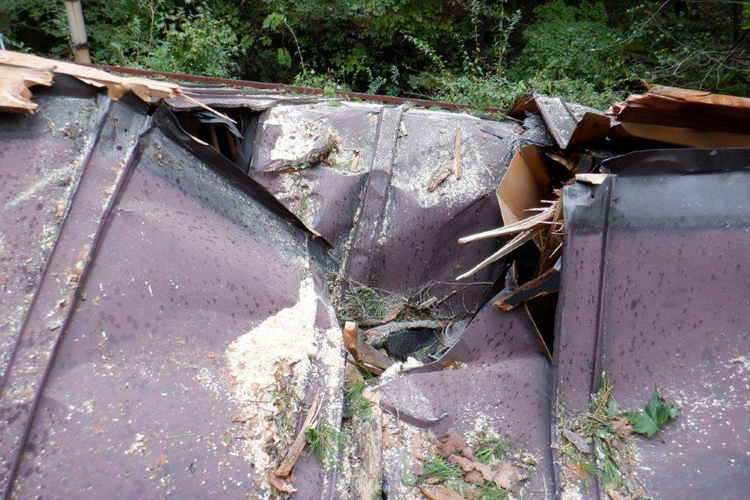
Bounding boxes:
0 79 102 378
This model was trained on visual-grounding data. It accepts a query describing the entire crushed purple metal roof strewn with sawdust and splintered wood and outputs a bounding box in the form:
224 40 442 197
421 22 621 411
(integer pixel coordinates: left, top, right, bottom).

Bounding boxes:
0 51 750 500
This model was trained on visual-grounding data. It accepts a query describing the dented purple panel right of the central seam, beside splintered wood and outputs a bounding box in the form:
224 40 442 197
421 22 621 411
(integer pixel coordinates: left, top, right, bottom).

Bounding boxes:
360 110 521 312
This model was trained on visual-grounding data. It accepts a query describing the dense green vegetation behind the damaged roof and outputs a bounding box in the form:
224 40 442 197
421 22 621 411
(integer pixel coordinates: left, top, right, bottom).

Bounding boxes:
0 0 750 108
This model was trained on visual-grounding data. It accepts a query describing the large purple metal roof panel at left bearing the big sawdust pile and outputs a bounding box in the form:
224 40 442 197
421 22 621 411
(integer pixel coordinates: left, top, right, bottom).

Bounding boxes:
0 80 344 499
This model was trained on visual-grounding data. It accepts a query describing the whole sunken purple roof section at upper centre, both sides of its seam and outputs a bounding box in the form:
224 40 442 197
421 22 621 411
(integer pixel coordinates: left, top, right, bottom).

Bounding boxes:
250 103 522 313
